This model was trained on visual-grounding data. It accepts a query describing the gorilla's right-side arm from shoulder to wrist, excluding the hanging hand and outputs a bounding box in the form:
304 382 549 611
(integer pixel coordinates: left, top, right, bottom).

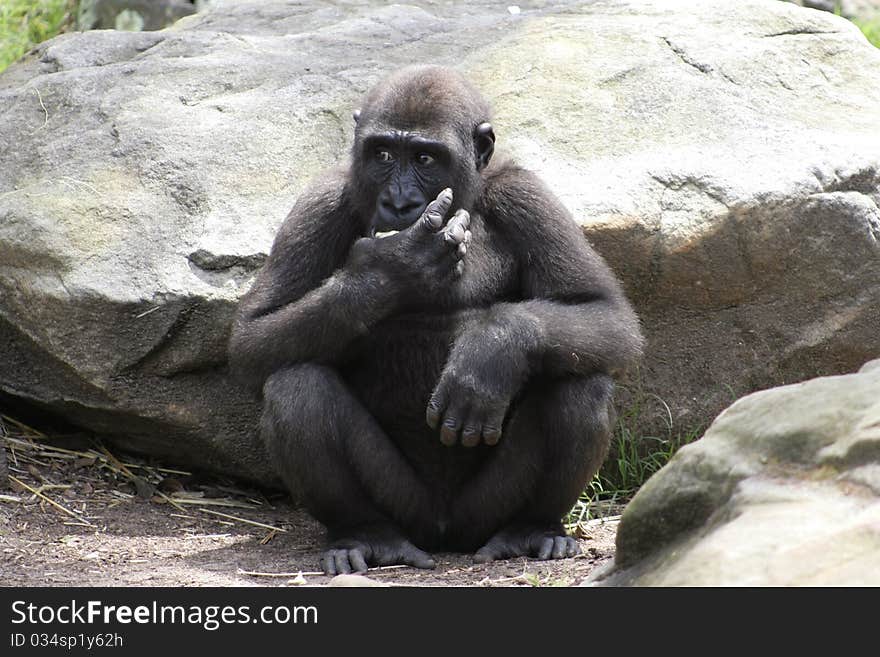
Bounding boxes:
470 166 643 376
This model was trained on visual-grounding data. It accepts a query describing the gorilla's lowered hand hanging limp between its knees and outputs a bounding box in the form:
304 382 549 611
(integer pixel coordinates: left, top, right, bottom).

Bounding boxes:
426 326 528 447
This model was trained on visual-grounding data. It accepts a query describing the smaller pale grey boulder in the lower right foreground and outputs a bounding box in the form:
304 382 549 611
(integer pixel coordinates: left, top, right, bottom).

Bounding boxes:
594 360 880 586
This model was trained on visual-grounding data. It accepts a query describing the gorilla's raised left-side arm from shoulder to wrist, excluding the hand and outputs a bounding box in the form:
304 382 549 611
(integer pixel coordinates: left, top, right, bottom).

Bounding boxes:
229 177 374 387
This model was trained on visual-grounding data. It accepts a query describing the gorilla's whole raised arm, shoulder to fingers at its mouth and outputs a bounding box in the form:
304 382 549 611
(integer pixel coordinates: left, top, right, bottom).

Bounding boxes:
229 179 467 388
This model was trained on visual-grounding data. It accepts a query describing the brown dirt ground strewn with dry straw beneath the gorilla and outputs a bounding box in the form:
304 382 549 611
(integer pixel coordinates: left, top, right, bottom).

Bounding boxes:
0 416 617 586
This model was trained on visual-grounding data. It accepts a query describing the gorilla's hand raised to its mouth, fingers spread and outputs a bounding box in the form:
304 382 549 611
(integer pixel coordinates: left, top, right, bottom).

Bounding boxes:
346 189 471 299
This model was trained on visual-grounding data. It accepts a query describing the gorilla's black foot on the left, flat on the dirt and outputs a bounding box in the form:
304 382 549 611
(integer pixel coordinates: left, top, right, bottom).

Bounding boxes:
321 531 436 575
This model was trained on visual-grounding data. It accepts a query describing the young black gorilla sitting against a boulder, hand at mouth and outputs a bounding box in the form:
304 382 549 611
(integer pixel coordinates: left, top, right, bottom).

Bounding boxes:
230 67 642 574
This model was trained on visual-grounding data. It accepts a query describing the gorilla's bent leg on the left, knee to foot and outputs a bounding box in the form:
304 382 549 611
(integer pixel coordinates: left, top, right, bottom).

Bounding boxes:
261 364 434 574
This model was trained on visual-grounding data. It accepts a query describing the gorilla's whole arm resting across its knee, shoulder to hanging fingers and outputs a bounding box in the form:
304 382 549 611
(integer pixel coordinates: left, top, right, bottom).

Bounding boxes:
427 167 643 446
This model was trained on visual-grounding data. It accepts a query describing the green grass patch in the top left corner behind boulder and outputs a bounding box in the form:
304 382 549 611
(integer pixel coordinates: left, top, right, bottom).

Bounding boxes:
0 0 76 71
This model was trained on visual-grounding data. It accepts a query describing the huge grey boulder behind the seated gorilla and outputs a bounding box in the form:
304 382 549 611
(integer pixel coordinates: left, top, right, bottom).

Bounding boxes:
0 0 880 477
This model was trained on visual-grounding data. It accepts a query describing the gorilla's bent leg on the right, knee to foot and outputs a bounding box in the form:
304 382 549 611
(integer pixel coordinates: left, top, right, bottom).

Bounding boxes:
452 375 614 561
